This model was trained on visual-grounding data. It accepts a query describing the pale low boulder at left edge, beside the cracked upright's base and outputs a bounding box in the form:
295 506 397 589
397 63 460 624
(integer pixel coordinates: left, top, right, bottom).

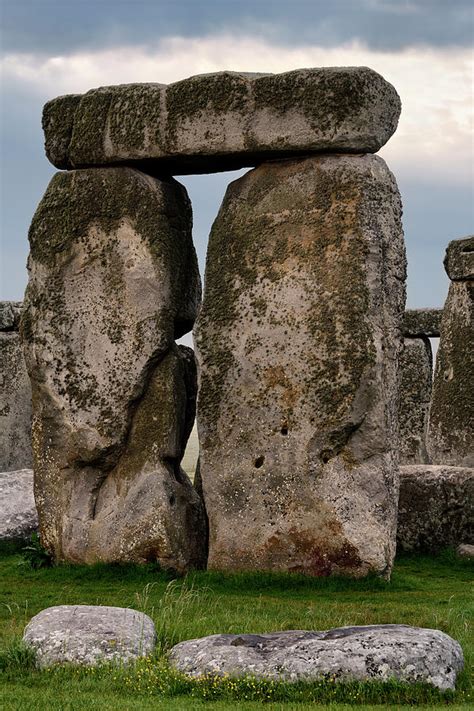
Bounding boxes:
0 469 38 541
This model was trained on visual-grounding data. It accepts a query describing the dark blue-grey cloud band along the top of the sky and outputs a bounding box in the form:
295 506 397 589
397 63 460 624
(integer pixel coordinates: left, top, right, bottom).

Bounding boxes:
2 0 473 56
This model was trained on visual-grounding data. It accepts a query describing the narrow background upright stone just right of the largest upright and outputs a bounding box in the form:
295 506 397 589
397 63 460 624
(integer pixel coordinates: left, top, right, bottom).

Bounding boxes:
398 338 433 464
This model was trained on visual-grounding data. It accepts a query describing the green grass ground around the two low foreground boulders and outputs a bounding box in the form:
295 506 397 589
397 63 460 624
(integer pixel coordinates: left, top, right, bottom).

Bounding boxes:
0 549 474 711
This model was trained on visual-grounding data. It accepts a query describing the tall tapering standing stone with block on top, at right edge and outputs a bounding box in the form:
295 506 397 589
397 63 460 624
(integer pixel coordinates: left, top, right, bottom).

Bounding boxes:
428 236 474 467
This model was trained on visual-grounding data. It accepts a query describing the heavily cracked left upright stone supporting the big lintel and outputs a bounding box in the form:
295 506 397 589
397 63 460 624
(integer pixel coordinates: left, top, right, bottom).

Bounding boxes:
22 168 205 570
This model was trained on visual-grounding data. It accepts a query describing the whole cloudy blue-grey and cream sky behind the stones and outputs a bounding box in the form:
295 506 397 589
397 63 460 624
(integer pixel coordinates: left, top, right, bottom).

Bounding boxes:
0 0 474 314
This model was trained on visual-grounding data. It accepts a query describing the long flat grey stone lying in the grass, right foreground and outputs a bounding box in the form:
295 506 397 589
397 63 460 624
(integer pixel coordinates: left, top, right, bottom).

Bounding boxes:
170 625 464 689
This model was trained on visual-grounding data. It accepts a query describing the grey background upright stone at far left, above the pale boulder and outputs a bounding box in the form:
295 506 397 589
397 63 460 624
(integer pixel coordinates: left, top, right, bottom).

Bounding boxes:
0 334 33 472
